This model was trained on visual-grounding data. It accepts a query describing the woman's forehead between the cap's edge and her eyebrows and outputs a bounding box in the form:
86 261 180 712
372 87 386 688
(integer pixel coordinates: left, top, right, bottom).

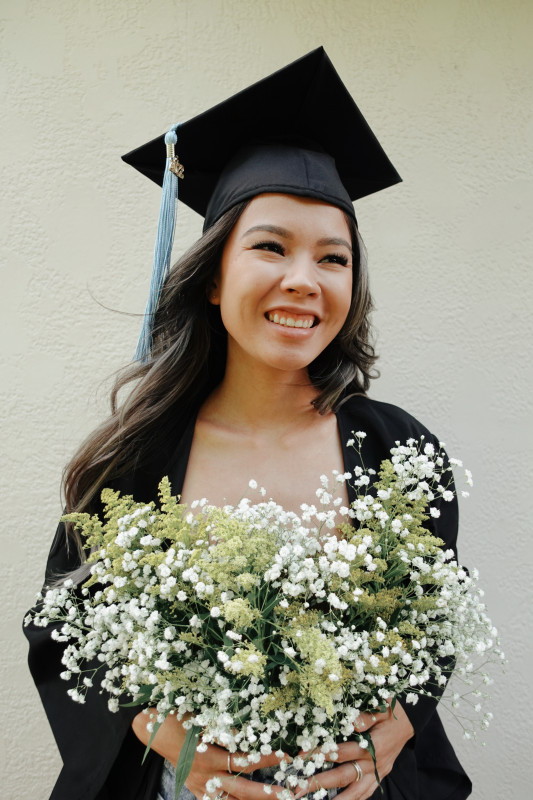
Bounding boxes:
234 194 351 241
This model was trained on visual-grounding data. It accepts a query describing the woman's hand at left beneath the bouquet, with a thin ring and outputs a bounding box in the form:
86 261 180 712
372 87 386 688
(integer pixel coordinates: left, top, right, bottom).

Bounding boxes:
132 713 290 800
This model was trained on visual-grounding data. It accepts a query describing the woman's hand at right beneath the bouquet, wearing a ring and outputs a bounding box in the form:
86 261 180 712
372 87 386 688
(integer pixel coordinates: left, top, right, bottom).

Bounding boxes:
295 703 414 800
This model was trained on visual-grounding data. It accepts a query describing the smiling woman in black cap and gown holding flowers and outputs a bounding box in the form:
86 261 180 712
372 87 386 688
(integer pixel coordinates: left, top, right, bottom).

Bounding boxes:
28 49 470 800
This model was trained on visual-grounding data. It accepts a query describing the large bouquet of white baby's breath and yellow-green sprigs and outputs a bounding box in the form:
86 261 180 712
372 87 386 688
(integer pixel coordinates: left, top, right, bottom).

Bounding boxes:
28 433 502 796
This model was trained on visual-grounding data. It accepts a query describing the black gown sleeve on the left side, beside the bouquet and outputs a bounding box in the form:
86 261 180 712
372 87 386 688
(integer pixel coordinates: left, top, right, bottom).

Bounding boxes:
24 523 162 800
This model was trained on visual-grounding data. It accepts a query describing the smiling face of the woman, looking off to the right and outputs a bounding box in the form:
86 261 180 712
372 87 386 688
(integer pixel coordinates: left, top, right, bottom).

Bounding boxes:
210 194 353 380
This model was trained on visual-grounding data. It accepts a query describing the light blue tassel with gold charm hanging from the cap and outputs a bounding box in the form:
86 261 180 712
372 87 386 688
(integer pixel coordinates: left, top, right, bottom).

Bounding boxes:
135 123 183 361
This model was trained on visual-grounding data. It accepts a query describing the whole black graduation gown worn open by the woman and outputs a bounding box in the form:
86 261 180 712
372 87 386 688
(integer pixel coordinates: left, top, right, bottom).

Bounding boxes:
25 395 471 800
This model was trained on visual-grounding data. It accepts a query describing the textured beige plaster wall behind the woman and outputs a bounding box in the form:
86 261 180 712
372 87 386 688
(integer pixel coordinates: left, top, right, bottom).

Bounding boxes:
0 0 533 800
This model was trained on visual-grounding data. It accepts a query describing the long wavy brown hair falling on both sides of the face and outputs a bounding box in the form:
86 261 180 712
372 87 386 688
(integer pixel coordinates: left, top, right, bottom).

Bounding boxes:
63 203 377 512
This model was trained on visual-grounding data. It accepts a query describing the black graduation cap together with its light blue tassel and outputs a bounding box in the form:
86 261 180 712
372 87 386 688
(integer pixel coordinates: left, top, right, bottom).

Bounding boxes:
123 47 401 360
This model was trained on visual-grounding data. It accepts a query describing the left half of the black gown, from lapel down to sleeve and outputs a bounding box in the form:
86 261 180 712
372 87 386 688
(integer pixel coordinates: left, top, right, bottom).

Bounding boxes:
24 408 195 800
